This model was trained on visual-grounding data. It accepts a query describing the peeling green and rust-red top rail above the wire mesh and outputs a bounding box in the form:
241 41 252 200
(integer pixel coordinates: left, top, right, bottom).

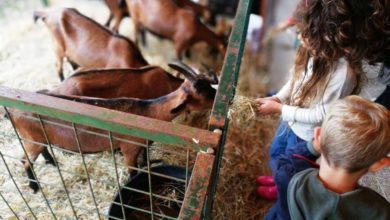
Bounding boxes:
0 86 220 151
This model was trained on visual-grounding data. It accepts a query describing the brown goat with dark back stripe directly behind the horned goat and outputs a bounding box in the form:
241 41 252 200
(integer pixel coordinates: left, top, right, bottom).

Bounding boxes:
52 66 183 99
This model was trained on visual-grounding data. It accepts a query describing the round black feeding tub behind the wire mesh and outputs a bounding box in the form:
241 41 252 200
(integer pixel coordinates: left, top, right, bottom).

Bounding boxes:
108 165 191 220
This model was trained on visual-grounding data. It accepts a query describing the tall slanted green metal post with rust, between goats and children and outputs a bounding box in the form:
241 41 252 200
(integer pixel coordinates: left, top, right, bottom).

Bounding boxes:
203 0 253 219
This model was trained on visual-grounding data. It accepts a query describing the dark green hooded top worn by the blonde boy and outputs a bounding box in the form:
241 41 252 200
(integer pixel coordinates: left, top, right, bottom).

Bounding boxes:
287 168 390 220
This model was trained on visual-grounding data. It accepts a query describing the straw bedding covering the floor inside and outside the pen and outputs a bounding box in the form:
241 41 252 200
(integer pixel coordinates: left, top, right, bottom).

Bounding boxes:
0 0 278 219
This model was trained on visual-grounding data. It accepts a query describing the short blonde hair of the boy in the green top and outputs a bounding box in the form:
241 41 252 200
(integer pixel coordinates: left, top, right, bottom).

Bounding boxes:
320 96 390 173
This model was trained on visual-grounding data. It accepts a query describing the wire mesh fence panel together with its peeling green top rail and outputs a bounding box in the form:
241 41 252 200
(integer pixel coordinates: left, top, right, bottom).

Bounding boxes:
0 88 219 219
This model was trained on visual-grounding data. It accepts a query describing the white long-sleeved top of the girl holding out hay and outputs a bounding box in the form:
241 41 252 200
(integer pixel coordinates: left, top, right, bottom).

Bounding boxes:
275 59 356 141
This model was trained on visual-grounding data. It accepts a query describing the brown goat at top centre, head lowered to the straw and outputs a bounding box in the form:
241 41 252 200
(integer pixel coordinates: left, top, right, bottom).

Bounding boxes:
126 0 225 58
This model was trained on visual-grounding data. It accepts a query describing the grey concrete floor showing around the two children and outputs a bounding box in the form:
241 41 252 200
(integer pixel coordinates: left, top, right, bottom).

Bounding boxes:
268 0 390 201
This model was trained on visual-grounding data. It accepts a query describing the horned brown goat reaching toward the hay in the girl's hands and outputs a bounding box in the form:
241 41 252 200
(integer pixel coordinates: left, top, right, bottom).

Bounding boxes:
10 64 216 192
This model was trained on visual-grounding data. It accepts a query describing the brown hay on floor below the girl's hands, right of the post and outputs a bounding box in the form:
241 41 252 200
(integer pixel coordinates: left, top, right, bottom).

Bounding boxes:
214 114 278 219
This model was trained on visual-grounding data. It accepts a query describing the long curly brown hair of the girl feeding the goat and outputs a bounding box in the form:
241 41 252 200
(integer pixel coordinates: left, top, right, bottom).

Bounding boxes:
290 0 390 106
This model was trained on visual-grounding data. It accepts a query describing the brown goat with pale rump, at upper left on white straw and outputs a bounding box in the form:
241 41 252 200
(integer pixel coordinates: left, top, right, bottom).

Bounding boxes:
34 8 148 80
